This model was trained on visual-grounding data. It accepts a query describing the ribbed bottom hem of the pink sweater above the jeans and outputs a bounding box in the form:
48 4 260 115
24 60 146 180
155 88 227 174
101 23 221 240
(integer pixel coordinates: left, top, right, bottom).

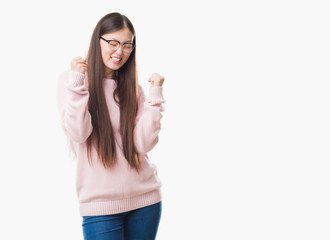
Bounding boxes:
80 189 161 216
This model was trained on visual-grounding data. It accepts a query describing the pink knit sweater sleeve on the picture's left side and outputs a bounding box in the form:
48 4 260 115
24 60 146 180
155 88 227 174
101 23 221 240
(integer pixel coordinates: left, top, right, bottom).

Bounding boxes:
57 71 93 143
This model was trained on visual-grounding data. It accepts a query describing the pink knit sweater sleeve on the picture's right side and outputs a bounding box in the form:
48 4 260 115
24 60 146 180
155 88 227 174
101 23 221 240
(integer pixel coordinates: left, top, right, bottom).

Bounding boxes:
134 87 165 154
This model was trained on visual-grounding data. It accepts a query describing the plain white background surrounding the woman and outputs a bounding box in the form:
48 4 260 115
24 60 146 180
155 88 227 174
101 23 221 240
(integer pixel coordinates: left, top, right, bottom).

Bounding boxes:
0 0 330 240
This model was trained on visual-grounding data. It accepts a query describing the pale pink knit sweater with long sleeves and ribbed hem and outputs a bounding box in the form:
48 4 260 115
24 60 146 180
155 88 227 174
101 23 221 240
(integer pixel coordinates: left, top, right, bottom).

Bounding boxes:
58 71 164 216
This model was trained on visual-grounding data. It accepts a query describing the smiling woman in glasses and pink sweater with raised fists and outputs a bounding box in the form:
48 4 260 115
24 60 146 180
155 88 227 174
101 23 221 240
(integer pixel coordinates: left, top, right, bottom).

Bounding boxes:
58 13 164 240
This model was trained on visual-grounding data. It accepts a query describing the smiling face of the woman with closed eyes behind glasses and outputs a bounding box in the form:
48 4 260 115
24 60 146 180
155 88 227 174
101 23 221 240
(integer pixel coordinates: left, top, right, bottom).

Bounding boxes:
100 27 133 78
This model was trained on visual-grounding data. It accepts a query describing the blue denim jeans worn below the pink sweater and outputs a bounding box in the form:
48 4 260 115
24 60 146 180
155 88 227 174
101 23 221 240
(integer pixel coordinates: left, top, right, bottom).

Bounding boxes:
82 202 162 240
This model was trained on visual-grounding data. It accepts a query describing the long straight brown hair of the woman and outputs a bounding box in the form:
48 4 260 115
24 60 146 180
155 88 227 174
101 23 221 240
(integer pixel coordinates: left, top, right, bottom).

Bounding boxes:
87 13 141 170
